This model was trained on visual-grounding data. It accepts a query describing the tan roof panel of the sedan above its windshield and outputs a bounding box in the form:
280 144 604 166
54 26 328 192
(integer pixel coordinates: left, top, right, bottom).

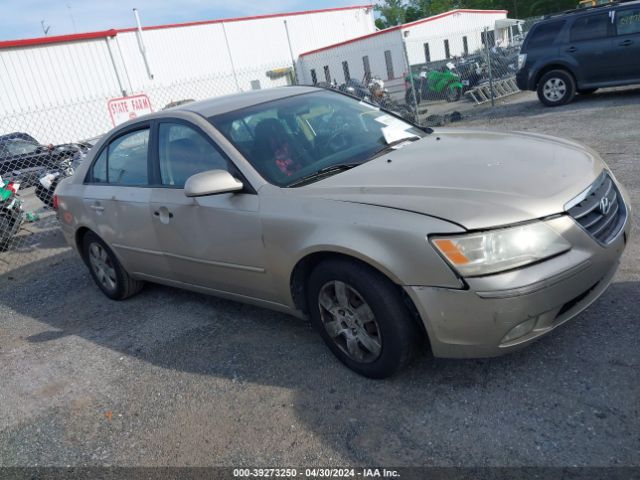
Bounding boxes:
165 86 323 117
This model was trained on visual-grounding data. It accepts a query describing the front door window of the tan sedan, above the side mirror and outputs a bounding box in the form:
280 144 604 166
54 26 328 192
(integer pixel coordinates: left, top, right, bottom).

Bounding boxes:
158 123 229 187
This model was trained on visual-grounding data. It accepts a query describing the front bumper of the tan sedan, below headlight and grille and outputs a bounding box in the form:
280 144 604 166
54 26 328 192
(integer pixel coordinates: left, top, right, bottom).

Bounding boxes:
405 215 631 358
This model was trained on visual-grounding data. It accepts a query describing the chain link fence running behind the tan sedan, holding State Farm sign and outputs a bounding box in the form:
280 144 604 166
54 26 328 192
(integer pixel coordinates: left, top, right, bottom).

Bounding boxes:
0 14 535 274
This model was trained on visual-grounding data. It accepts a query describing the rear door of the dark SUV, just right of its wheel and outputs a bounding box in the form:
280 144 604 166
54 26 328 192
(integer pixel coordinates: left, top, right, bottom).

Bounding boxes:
561 12 613 84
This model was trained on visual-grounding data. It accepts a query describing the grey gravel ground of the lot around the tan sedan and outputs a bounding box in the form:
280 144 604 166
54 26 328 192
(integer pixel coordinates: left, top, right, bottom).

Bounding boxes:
0 90 640 466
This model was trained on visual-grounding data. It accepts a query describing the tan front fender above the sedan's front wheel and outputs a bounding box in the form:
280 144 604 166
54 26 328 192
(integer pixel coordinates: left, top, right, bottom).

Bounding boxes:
261 195 464 305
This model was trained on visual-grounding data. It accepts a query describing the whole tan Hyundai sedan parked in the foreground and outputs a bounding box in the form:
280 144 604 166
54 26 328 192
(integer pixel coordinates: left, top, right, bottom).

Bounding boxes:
54 87 631 378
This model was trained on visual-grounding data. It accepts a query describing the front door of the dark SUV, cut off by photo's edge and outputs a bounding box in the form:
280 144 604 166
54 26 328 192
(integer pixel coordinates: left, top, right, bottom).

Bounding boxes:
612 5 640 82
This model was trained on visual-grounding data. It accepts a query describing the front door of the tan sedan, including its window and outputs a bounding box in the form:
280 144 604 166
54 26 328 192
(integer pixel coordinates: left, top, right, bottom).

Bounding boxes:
151 120 273 300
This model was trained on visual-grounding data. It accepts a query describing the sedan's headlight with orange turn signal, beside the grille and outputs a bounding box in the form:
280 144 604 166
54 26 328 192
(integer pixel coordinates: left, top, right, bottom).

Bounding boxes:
431 222 571 277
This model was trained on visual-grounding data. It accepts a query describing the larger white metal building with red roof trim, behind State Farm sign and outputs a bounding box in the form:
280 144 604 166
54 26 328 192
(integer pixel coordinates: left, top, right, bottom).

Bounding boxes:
0 5 375 143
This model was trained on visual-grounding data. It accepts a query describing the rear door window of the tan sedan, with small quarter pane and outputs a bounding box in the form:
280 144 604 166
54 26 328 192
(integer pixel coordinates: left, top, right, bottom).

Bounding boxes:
87 128 149 186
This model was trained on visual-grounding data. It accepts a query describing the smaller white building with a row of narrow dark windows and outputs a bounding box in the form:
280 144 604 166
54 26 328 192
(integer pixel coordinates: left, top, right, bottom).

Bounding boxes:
298 9 508 87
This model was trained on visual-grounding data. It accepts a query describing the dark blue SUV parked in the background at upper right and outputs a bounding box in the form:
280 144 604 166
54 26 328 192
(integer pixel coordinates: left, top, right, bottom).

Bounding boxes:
516 0 640 107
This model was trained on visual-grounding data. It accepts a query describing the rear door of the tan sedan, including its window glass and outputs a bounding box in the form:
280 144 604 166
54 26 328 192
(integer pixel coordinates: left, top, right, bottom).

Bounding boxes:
83 124 167 276
